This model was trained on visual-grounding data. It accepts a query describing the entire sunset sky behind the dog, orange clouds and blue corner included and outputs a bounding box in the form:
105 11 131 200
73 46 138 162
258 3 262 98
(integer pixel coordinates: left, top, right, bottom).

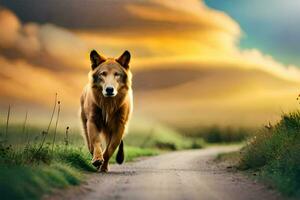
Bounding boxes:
0 0 300 126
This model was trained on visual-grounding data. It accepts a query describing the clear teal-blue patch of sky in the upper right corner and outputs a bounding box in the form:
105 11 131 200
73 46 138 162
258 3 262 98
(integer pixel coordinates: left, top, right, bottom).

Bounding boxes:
205 0 300 66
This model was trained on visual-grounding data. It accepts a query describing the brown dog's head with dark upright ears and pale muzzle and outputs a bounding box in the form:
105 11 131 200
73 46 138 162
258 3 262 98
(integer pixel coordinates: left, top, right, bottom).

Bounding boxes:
90 50 131 97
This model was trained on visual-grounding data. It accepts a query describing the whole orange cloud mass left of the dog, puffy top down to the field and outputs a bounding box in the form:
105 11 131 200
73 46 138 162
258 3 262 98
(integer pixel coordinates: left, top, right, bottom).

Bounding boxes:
0 8 89 121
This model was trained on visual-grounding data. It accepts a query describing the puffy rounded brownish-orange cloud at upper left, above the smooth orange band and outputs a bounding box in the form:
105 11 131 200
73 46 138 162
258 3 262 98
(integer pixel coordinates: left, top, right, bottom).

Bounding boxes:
0 8 88 69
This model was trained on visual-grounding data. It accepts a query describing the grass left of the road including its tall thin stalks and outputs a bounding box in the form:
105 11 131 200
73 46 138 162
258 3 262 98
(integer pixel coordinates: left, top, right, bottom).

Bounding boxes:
0 99 159 199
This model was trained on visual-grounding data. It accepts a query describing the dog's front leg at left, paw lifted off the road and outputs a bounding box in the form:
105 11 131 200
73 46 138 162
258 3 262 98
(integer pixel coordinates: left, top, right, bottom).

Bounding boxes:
87 120 104 168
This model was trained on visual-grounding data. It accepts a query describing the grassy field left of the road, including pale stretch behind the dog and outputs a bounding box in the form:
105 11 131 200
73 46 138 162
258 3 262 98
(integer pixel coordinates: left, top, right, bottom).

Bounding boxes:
0 114 204 199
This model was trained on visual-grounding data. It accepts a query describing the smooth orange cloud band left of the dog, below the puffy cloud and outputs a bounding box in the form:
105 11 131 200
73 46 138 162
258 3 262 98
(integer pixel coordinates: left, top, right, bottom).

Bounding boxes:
0 54 86 109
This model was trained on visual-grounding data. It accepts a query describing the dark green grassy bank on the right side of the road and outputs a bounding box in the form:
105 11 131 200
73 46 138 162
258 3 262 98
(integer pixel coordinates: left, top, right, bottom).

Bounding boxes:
238 112 300 198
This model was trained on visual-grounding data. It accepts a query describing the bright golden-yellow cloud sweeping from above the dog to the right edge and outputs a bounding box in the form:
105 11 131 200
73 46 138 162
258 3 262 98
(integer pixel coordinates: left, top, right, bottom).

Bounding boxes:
73 0 300 82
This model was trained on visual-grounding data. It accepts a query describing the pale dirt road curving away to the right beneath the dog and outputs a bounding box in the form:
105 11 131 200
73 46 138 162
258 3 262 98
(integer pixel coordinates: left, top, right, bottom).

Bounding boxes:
47 146 281 200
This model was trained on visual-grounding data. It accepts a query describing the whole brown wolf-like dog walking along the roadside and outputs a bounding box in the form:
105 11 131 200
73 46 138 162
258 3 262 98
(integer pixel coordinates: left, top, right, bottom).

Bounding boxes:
80 50 132 172
